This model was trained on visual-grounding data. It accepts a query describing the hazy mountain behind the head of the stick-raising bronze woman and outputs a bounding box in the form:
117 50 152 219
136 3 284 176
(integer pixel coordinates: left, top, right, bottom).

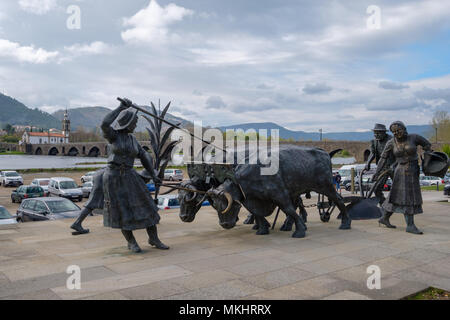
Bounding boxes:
52 107 192 132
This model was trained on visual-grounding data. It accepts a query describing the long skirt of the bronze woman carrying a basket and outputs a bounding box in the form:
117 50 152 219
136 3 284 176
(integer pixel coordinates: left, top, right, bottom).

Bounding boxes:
383 160 423 214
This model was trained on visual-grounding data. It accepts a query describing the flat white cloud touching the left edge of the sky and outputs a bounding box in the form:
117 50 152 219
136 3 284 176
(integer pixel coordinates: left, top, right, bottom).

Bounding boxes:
0 39 59 63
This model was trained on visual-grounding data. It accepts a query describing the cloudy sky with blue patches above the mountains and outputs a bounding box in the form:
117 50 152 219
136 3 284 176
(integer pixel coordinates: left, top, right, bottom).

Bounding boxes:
0 0 450 132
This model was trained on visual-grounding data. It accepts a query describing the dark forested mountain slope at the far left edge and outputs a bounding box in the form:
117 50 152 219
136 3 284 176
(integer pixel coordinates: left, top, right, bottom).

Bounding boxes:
0 93 61 128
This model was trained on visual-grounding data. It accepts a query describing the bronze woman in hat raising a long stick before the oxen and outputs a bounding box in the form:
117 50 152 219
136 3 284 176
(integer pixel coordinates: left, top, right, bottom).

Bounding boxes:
101 99 169 252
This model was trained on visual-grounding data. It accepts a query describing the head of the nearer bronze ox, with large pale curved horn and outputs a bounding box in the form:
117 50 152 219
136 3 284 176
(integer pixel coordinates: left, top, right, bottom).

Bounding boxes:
208 180 242 229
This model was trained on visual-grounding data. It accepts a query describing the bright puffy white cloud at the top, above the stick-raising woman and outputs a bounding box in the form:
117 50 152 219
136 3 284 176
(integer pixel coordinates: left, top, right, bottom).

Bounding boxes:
121 0 194 43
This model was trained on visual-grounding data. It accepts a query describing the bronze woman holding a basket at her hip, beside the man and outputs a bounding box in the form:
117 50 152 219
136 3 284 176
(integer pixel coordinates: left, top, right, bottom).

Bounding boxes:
375 121 431 234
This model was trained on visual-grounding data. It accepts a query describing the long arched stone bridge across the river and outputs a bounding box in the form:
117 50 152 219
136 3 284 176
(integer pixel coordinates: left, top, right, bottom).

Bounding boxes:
20 140 445 163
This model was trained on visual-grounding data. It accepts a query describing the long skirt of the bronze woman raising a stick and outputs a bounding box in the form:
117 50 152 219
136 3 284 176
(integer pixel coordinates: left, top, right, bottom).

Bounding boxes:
103 166 160 230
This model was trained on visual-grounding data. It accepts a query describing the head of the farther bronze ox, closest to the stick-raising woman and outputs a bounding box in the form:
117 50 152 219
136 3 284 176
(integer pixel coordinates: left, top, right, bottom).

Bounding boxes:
178 181 205 222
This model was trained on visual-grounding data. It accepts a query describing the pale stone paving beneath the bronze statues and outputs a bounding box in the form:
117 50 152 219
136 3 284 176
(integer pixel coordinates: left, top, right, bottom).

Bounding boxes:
0 192 450 300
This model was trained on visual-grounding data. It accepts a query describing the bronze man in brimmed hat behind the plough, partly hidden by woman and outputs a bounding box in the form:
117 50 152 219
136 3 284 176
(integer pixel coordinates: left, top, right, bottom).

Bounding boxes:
365 123 395 205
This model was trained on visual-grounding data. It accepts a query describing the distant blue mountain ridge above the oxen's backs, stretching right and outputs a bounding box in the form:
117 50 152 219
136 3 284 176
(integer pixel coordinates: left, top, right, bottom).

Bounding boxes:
219 122 432 141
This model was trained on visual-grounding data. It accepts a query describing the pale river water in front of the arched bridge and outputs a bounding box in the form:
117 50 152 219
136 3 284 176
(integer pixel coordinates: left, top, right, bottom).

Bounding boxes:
0 155 355 170
